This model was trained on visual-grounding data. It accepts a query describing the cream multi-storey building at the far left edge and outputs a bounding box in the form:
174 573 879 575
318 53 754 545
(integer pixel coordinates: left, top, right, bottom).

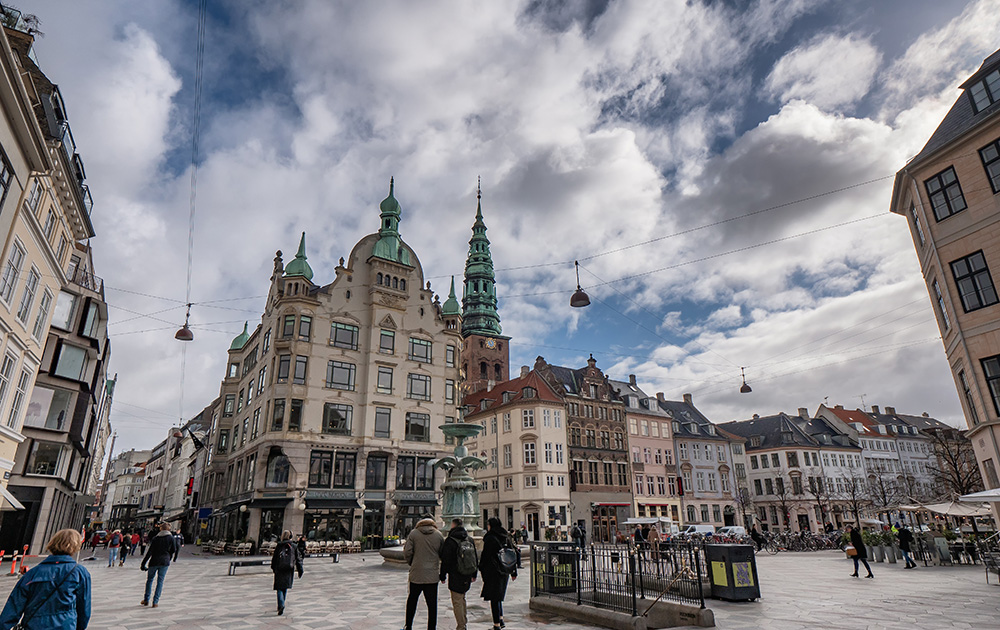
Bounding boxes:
0 8 94 510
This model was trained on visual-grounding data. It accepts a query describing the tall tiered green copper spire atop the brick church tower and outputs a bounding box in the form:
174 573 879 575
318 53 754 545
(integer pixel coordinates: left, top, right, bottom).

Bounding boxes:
462 183 500 337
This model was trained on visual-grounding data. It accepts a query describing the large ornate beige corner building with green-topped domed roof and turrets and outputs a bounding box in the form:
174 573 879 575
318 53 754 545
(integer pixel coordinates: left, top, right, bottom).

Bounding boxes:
205 183 462 546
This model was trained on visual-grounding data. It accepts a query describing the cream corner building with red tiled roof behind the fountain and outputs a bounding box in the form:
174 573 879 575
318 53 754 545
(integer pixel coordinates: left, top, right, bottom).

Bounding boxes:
465 367 570 540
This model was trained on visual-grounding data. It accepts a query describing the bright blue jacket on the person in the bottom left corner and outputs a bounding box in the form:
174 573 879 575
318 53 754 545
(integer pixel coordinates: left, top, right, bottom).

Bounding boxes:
0 555 90 630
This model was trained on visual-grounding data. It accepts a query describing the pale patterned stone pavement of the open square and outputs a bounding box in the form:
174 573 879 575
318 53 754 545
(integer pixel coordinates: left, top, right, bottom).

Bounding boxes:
0 547 1000 630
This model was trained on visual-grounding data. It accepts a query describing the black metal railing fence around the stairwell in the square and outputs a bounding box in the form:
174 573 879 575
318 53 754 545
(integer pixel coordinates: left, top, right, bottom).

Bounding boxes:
530 542 707 616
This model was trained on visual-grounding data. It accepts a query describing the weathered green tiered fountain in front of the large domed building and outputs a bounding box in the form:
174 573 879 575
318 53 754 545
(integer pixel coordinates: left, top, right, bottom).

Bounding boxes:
379 422 486 564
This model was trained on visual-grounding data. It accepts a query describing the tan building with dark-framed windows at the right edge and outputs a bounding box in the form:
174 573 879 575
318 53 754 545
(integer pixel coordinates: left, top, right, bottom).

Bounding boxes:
890 45 1000 516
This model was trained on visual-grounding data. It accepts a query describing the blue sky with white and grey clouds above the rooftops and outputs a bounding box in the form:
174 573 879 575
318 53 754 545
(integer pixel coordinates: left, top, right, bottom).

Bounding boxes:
19 0 1000 448
